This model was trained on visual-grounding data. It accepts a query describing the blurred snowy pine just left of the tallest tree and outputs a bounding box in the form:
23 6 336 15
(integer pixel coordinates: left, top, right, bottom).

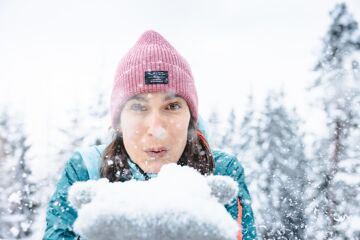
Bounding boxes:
253 93 308 239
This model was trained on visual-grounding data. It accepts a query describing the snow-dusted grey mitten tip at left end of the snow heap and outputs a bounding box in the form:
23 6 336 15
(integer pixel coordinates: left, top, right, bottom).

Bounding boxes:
68 178 109 209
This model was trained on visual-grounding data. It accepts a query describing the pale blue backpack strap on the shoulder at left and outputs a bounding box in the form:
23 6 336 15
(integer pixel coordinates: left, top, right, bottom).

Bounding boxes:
78 145 106 180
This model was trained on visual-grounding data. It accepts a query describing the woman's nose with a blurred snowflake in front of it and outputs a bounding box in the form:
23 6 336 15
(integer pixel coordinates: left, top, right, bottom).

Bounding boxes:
146 111 167 139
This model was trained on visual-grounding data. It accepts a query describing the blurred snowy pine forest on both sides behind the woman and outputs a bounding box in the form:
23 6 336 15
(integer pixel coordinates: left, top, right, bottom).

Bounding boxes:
0 1 360 239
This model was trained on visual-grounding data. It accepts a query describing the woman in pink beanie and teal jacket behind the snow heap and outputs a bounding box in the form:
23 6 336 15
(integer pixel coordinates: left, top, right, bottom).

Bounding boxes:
44 31 256 239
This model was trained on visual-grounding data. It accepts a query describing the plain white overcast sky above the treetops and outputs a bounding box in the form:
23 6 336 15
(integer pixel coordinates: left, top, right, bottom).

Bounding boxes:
0 0 360 152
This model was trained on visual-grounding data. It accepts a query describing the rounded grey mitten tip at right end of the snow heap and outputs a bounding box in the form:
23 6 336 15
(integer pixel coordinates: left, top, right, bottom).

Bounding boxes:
206 175 239 204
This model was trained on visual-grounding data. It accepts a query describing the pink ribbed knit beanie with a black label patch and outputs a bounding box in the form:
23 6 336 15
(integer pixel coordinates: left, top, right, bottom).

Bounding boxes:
111 31 198 129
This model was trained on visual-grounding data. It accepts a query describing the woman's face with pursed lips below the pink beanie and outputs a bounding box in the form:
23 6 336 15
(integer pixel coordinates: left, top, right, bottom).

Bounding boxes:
120 92 190 173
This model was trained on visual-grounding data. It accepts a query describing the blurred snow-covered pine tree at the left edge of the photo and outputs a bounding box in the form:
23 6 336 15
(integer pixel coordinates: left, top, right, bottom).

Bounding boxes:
0 110 38 239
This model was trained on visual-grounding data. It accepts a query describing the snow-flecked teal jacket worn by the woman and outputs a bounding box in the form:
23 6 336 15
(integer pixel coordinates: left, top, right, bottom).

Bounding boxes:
43 145 256 240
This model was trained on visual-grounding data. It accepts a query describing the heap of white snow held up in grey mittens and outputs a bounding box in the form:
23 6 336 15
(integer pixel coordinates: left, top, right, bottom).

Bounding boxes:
69 164 239 240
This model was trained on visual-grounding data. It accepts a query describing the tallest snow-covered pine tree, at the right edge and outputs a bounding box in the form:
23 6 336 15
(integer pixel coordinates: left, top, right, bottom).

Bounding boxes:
312 3 360 239
